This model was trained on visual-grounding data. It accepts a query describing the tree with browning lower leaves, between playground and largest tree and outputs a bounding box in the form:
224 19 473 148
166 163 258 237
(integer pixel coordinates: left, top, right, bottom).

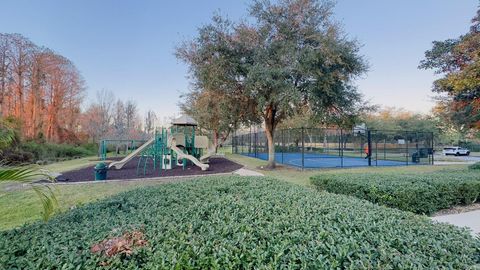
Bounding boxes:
176 16 260 152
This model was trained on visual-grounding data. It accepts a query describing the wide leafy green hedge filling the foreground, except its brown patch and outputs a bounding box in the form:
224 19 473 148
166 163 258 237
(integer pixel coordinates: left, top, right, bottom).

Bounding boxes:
0 176 480 269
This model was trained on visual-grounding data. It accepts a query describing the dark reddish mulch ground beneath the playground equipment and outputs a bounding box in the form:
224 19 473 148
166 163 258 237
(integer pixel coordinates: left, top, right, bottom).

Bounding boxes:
57 158 243 182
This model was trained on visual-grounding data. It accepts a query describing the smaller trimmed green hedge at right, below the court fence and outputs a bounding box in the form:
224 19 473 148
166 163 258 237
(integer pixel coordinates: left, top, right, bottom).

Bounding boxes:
311 170 480 215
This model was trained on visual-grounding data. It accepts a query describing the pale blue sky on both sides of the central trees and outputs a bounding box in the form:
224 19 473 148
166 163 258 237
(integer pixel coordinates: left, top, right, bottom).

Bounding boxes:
0 0 479 119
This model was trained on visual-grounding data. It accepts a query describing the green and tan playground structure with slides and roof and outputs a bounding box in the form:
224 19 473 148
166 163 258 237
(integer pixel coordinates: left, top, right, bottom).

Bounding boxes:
101 116 215 175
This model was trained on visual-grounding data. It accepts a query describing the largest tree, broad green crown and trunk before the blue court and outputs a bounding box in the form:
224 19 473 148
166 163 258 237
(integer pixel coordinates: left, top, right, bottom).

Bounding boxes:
177 0 367 167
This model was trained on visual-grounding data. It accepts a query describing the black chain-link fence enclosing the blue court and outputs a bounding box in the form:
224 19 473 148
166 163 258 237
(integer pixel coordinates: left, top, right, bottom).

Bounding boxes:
232 128 434 169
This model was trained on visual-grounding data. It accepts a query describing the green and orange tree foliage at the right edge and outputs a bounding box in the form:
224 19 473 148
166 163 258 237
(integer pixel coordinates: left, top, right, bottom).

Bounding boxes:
419 9 480 130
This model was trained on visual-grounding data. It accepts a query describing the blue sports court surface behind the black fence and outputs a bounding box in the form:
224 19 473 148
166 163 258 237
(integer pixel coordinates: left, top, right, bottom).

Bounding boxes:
242 153 405 168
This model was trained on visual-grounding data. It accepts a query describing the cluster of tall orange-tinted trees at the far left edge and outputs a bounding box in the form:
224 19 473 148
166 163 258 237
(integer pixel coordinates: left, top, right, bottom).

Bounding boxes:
0 33 84 143
